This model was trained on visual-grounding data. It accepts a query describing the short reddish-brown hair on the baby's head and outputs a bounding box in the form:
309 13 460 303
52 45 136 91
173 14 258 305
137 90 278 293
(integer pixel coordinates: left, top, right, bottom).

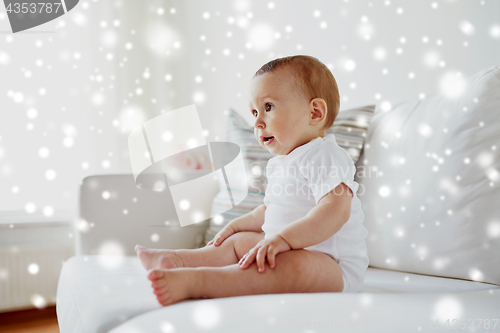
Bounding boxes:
253 55 340 130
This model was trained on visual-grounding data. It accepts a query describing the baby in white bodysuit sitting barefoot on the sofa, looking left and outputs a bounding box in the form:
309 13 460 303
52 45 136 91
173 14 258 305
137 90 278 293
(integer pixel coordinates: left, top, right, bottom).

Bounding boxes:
135 55 368 305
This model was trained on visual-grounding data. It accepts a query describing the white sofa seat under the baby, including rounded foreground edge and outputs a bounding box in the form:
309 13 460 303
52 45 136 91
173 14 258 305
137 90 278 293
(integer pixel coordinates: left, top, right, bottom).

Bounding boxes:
57 256 500 333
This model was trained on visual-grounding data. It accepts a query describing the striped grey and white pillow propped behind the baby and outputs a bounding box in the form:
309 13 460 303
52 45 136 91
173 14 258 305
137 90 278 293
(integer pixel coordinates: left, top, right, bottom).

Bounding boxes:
203 105 375 246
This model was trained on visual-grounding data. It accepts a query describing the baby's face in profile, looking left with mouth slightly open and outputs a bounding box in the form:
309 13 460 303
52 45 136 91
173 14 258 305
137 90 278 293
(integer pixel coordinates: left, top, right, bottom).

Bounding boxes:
250 69 317 155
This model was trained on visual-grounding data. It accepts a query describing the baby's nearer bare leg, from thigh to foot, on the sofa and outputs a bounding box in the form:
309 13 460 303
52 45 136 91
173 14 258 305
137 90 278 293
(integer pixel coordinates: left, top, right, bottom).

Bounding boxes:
148 250 344 305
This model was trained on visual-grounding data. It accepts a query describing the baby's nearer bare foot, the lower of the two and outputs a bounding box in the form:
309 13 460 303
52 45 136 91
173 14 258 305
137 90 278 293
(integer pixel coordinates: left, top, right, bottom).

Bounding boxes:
148 269 192 306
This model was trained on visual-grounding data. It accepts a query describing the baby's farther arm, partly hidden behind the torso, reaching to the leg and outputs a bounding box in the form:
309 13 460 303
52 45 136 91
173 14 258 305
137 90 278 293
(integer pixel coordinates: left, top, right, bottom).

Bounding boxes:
206 204 266 246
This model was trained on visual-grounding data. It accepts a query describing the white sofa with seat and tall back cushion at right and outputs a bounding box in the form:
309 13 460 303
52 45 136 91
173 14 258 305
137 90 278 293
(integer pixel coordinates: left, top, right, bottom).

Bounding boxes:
57 66 500 333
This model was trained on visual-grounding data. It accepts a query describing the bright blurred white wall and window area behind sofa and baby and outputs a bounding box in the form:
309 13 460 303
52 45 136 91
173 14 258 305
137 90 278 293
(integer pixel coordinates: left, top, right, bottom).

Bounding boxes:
0 0 500 322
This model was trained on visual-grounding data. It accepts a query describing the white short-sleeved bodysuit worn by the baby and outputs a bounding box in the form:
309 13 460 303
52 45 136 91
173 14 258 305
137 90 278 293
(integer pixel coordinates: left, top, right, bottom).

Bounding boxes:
262 134 368 292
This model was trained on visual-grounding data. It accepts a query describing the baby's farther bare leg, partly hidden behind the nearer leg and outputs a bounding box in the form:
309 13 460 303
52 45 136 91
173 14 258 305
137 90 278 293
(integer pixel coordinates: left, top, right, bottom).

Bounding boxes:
135 231 264 270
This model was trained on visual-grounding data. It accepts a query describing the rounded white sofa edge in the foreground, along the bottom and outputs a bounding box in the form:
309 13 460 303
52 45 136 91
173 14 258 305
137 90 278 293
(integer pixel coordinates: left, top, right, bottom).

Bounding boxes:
111 290 499 333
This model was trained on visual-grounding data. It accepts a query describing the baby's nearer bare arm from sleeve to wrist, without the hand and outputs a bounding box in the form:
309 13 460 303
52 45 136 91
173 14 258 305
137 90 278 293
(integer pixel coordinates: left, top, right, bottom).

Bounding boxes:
278 183 352 250
